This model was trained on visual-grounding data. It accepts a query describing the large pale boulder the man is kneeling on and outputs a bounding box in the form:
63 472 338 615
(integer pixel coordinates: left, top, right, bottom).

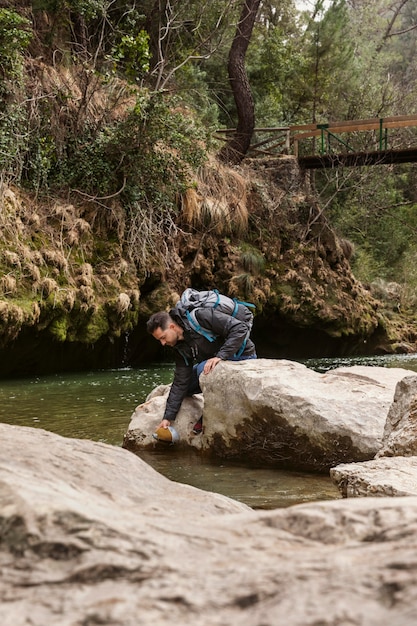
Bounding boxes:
124 359 417 471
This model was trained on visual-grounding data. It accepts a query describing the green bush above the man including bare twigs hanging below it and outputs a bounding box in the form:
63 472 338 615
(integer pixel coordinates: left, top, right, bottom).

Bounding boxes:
33 91 210 268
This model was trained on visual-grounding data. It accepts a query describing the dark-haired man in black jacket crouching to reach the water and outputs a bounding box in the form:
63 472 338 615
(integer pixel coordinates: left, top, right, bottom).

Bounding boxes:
147 304 256 435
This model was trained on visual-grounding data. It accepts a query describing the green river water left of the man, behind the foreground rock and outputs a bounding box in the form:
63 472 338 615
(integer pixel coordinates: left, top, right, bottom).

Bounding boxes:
0 365 173 446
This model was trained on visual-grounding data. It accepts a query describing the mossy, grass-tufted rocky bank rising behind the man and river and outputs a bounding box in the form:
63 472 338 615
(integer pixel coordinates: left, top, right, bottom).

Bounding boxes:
0 157 415 375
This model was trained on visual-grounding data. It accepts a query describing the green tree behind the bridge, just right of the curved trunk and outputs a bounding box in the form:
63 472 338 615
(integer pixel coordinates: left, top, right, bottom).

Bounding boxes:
247 0 359 126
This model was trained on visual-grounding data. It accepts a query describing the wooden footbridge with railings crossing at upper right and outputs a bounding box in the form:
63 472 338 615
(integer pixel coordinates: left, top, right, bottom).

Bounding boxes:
214 115 417 169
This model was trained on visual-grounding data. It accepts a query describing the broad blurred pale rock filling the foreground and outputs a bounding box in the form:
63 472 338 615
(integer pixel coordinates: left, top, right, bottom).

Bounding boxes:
4 425 417 626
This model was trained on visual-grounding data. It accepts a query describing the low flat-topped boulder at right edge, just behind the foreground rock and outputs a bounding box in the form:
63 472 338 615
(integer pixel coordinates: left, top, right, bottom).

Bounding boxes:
330 456 417 498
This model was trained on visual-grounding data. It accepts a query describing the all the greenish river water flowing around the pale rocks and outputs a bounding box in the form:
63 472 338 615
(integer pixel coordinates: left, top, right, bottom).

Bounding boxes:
0 355 417 509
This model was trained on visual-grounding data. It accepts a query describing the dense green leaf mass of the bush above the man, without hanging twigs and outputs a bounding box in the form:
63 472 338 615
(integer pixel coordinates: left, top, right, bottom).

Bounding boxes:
57 91 206 197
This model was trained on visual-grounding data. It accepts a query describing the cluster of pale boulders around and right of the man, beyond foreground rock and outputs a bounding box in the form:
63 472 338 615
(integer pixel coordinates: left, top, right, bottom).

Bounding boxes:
123 359 417 497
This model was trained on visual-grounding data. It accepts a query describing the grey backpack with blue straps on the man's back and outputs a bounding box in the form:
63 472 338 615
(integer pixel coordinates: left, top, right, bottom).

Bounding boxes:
176 287 255 356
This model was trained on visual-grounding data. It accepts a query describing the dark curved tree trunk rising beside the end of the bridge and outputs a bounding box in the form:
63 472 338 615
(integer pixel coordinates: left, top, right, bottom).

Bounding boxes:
219 0 261 165
